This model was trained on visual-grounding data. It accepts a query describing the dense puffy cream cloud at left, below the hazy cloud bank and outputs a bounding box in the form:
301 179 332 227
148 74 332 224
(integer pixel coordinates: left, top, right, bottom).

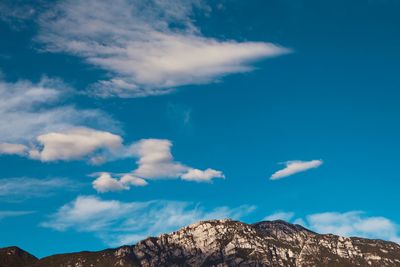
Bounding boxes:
30 127 122 162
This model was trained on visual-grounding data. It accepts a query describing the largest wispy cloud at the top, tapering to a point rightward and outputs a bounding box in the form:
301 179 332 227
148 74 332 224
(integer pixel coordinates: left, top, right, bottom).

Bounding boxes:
37 0 289 97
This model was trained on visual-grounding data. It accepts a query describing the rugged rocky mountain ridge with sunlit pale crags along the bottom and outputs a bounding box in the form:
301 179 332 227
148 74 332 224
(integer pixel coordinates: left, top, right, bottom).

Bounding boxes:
0 220 400 267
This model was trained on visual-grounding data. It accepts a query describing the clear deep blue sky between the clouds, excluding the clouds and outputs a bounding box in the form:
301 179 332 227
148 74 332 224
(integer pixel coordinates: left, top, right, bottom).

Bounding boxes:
0 0 400 256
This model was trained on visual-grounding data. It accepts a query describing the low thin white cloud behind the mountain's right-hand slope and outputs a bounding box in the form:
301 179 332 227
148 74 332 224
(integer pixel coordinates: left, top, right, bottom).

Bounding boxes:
265 211 400 243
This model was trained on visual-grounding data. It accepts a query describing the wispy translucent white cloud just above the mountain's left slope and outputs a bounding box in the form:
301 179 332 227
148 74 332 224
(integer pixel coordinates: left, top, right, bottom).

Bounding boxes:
42 196 254 246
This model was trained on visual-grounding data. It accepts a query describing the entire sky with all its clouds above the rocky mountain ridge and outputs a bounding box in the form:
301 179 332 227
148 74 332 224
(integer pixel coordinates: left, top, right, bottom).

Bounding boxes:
0 0 400 256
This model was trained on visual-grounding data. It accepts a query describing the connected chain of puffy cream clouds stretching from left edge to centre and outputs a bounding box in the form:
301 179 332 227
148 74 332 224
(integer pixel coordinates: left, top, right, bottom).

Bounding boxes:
0 130 225 185
